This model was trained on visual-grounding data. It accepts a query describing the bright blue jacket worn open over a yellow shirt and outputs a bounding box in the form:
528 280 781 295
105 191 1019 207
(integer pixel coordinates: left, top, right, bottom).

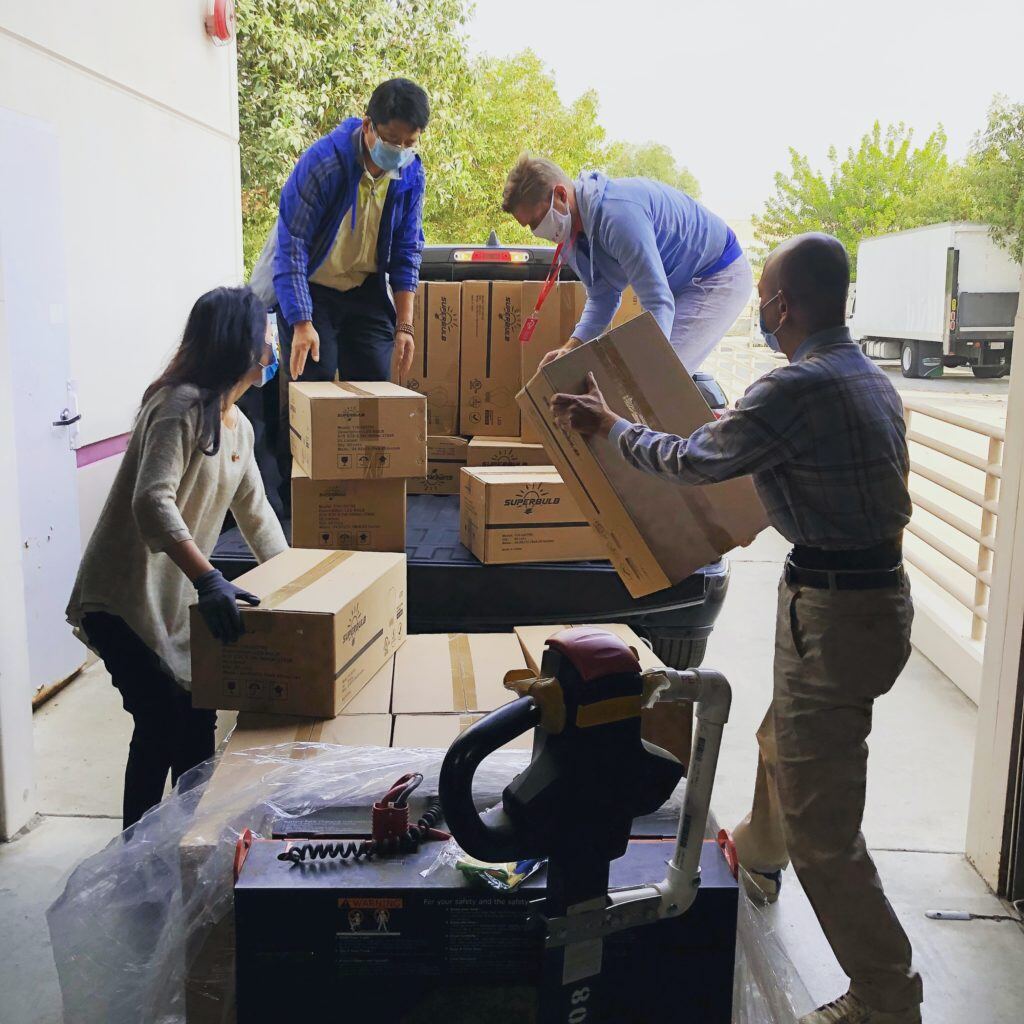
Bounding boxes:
273 118 426 324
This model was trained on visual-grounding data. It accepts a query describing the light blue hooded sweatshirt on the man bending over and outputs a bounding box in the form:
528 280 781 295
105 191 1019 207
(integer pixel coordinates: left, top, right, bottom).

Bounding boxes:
567 171 742 341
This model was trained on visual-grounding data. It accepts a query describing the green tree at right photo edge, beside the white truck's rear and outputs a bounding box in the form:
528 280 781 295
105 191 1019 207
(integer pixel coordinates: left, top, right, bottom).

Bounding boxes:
964 96 1024 261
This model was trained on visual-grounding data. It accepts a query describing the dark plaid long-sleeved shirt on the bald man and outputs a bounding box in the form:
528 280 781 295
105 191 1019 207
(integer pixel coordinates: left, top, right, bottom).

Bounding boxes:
611 328 910 550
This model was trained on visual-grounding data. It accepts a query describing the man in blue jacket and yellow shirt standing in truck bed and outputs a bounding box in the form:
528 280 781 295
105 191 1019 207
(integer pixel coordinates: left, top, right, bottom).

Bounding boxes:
270 78 430 381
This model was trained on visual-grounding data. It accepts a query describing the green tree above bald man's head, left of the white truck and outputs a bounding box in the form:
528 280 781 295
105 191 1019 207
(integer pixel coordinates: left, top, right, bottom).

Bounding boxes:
754 122 975 274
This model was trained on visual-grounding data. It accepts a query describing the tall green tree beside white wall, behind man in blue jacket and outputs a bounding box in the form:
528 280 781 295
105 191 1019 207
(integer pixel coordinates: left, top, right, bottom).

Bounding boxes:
238 0 473 268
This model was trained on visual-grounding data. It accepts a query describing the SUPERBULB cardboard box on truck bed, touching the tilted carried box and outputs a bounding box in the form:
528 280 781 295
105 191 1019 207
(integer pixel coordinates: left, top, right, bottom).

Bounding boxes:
459 466 607 565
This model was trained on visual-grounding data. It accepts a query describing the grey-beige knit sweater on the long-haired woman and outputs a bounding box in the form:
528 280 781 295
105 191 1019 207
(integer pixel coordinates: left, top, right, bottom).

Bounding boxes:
68 385 288 688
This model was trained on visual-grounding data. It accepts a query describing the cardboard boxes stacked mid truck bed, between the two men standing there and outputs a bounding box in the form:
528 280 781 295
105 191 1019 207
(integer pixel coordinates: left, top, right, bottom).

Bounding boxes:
392 281 604 562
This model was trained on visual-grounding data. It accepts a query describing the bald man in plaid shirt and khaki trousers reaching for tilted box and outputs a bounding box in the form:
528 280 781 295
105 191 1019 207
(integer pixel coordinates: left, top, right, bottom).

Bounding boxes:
552 234 922 1024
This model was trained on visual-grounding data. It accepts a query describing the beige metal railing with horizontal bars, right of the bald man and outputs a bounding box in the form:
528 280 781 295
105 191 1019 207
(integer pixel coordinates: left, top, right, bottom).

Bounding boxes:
903 396 1006 640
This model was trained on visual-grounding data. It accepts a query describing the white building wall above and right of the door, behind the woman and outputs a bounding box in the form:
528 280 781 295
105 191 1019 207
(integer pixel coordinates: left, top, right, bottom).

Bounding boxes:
0 0 242 538
